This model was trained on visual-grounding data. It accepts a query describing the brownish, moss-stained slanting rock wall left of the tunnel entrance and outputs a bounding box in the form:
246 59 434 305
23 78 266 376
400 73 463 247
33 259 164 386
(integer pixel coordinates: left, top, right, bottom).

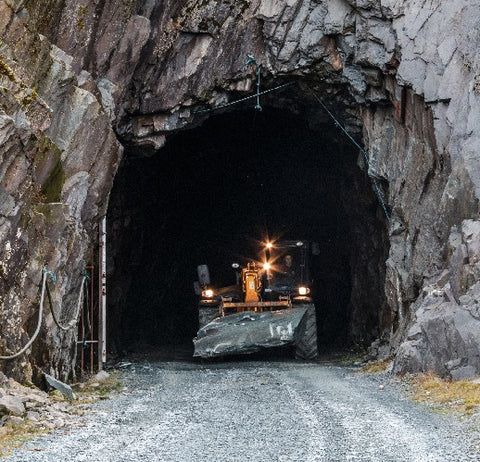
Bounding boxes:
0 2 121 379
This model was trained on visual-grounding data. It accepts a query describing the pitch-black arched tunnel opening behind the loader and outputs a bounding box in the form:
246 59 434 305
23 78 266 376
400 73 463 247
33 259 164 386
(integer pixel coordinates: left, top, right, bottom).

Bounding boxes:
107 108 386 354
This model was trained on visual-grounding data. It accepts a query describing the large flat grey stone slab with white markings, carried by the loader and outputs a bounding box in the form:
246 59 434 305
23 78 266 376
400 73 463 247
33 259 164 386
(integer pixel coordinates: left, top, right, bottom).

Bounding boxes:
193 307 307 358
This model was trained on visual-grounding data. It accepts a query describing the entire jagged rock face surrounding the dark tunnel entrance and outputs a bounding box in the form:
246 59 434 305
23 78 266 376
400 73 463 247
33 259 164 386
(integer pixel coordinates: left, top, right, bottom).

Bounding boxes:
0 0 480 379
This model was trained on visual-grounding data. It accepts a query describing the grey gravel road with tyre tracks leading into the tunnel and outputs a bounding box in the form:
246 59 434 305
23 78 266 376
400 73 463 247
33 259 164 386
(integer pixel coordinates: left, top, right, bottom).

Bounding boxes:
5 361 480 462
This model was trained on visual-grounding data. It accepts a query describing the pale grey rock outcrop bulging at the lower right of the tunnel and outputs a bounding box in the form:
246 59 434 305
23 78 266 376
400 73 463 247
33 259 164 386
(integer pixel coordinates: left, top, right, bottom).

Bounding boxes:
394 220 480 380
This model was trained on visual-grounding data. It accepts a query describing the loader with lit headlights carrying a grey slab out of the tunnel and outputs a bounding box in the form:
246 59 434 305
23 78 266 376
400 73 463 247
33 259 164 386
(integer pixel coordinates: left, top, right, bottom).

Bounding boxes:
193 240 318 360
